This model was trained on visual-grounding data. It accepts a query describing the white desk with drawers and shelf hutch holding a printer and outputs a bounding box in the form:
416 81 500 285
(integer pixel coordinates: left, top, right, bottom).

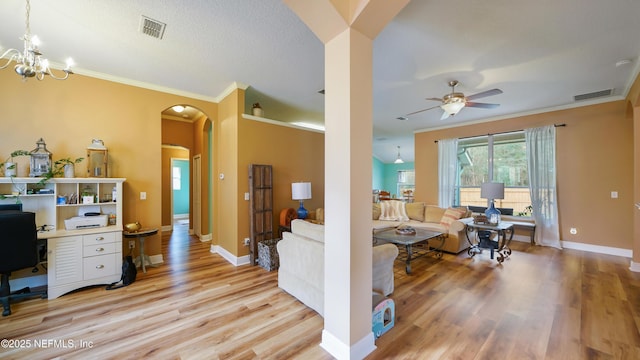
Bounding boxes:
0 178 126 299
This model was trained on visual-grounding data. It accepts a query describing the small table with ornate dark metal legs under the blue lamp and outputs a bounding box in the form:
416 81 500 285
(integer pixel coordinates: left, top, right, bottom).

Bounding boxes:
461 218 514 263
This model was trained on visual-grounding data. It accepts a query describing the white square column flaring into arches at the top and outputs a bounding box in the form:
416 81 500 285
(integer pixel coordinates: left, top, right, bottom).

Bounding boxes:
284 0 409 359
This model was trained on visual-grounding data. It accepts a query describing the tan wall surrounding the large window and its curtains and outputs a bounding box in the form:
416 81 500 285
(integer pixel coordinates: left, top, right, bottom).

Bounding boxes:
415 101 634 249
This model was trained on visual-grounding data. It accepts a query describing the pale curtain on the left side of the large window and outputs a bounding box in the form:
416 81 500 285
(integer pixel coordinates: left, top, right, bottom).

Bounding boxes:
438 139 458 208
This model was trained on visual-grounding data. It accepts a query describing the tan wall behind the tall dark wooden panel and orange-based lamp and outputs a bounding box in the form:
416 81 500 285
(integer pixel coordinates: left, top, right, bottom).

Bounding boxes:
238 119 324 255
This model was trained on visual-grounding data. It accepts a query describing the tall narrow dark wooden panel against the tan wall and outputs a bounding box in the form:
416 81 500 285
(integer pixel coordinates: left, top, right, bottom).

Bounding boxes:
249 164 273 265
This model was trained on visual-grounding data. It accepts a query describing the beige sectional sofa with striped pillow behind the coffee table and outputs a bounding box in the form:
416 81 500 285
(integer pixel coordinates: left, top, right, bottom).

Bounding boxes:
372 200 471 254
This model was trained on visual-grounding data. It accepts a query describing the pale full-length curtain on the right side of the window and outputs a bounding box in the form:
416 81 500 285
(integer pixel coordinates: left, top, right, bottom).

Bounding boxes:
524 125 562 249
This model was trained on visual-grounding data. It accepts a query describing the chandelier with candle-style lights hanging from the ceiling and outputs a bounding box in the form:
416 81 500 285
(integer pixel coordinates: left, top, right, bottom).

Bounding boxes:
0 0 73 81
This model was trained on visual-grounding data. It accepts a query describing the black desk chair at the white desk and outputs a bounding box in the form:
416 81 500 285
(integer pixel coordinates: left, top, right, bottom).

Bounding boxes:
0 210 47 316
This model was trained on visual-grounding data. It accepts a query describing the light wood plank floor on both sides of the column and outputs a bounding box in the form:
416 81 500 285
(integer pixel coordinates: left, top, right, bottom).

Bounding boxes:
0 225 640 360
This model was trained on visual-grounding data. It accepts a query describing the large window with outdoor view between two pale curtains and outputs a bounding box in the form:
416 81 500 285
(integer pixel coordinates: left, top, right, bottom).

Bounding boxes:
455 132 531 215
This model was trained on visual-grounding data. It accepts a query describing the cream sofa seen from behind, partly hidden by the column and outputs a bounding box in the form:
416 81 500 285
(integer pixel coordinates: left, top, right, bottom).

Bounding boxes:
277 219 398 315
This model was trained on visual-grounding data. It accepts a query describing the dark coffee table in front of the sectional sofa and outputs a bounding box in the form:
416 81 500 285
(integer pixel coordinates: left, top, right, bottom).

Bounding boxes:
373 228 445 274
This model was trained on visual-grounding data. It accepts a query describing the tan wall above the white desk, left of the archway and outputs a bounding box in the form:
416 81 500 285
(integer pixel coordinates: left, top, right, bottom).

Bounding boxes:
0 70 217 255
